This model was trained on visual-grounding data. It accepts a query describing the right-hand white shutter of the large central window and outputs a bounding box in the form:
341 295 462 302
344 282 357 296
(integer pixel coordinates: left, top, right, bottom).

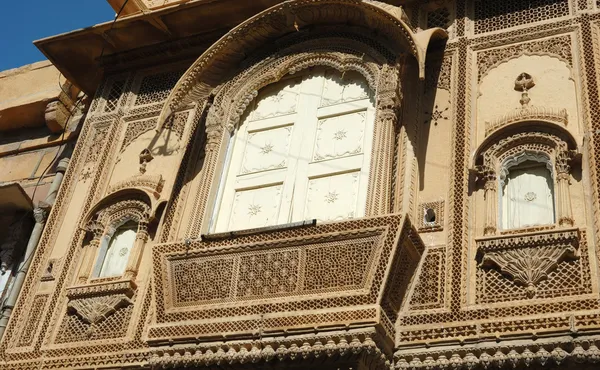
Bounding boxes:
295 72 374 221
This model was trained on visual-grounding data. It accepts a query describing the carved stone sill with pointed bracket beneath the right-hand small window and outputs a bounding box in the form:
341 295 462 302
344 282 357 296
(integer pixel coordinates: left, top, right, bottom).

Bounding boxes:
476 228 579 297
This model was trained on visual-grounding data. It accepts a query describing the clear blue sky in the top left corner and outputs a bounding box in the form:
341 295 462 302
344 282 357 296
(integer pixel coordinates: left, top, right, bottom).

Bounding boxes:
0 0 115 71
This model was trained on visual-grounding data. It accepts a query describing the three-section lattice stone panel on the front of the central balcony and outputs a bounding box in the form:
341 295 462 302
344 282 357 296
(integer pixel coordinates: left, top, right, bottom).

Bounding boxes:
167 231 381 306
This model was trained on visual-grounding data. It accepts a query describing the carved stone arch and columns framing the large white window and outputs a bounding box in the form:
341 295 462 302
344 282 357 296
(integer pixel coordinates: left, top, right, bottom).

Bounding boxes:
180 27 424 236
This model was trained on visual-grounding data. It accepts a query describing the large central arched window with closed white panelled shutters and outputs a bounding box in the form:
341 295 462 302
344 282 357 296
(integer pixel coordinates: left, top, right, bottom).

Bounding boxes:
211 70 375 232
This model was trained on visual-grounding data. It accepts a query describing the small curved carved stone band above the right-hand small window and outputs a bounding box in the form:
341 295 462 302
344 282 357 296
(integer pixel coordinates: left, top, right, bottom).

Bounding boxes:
485 105 569 136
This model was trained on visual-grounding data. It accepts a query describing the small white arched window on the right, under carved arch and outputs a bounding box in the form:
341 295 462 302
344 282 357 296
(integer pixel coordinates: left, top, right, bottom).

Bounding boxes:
500 153 555 229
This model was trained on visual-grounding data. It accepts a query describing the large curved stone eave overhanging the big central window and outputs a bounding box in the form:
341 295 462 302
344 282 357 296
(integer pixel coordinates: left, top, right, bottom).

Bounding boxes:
157 0 447 130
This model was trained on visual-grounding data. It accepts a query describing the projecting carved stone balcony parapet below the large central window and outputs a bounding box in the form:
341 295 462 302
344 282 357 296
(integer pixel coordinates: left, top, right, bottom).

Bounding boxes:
149 215 424 342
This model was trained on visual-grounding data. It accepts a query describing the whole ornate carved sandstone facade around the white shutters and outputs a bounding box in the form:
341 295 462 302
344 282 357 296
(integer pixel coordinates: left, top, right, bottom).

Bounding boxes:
5 0 600 369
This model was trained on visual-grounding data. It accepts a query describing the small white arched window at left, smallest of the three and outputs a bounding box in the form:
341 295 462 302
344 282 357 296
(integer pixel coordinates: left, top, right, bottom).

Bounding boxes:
94 221 138 277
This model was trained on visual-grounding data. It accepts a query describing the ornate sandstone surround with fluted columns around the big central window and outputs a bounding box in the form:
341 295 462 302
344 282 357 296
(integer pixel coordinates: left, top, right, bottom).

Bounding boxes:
182 46 403 236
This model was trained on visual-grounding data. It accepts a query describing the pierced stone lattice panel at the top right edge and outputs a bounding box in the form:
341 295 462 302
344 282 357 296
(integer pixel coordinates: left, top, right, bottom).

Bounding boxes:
474 0 569 34
